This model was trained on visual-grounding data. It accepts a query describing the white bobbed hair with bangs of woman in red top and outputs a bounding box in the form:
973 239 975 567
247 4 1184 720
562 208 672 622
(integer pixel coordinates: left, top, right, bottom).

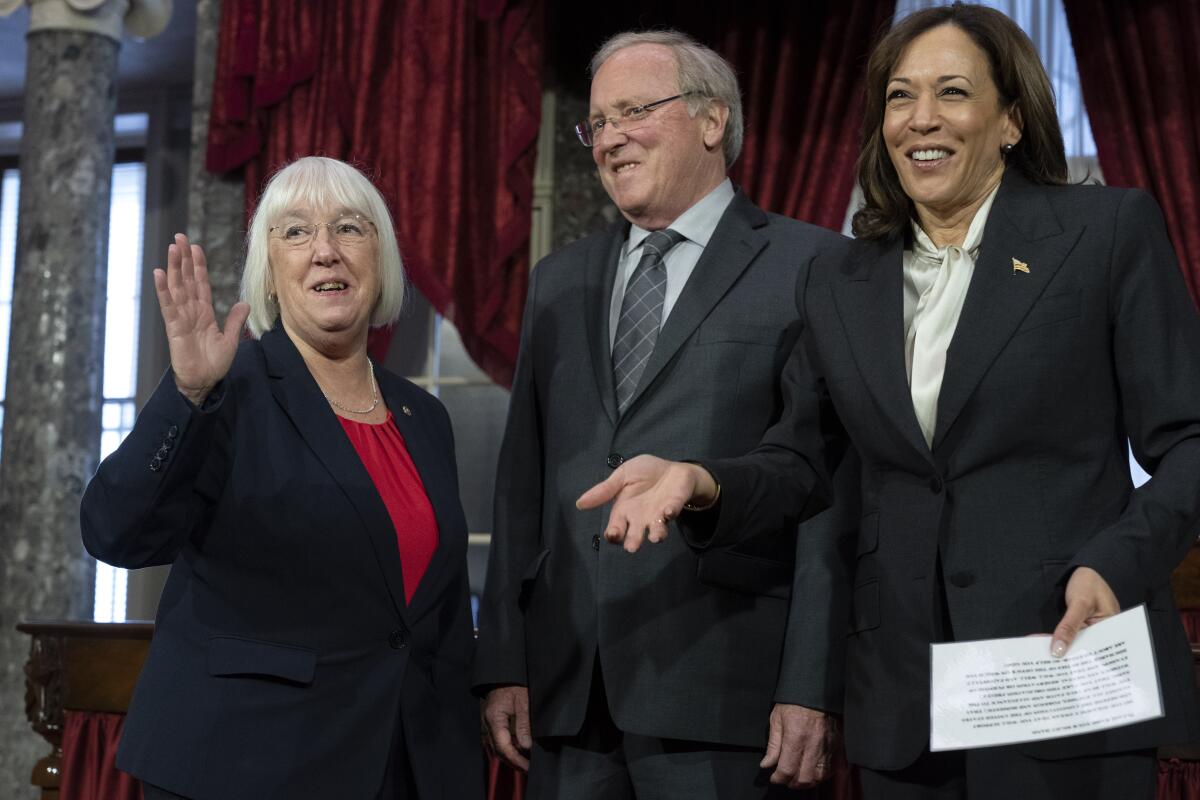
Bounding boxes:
241 156 404 338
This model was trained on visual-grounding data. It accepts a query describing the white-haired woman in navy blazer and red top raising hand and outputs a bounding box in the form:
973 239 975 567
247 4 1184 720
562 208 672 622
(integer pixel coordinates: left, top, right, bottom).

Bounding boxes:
82 153 482 800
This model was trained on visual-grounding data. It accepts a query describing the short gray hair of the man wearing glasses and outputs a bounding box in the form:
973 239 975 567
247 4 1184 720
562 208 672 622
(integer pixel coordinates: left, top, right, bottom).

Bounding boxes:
588 29 744 169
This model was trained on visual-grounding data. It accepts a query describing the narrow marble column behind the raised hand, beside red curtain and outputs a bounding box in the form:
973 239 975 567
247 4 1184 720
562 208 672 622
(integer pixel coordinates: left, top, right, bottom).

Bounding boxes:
187 0 246 323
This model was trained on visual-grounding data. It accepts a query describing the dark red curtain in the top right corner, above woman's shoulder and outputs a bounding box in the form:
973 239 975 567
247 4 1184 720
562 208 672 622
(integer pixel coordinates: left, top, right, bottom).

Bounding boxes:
1063 0 1200 305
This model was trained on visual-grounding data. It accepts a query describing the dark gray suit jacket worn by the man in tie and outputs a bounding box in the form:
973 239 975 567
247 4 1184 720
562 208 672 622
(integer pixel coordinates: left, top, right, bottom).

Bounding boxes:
474 194 857 746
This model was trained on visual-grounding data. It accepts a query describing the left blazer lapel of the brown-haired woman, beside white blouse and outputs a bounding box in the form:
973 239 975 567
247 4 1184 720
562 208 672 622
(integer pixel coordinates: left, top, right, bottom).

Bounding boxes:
833 236 930 461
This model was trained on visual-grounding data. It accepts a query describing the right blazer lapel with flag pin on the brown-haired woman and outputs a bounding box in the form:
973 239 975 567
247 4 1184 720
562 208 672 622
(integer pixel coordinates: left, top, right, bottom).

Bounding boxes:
934 172 1082 450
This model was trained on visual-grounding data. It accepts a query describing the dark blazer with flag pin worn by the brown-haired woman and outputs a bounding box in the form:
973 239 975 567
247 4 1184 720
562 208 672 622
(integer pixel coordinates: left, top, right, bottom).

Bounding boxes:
709 173 1200 769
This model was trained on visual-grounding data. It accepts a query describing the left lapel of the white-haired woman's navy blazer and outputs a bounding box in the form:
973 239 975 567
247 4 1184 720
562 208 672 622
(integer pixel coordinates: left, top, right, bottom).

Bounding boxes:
262 326 407 621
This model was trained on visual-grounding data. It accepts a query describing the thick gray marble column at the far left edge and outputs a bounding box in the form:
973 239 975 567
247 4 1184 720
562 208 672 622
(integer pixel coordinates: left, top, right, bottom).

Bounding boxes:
0 0 169 798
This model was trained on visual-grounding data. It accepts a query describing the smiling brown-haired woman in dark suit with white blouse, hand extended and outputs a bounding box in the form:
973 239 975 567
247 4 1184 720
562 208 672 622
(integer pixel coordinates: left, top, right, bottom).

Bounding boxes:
582 5 1200 800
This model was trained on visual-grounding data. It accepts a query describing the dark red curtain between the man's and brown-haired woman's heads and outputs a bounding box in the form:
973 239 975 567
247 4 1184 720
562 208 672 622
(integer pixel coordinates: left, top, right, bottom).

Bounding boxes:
713 0 895 230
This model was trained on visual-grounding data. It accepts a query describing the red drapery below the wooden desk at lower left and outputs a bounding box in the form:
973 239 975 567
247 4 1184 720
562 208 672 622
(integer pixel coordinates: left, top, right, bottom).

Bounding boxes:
59 711 142 800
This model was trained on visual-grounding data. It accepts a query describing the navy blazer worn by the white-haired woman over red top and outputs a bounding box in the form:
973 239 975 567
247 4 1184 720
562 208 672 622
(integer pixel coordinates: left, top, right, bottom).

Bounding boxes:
82 327 482 800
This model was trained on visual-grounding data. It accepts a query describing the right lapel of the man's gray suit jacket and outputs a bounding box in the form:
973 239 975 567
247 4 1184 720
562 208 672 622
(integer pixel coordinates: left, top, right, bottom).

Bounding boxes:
624 192 767 415
